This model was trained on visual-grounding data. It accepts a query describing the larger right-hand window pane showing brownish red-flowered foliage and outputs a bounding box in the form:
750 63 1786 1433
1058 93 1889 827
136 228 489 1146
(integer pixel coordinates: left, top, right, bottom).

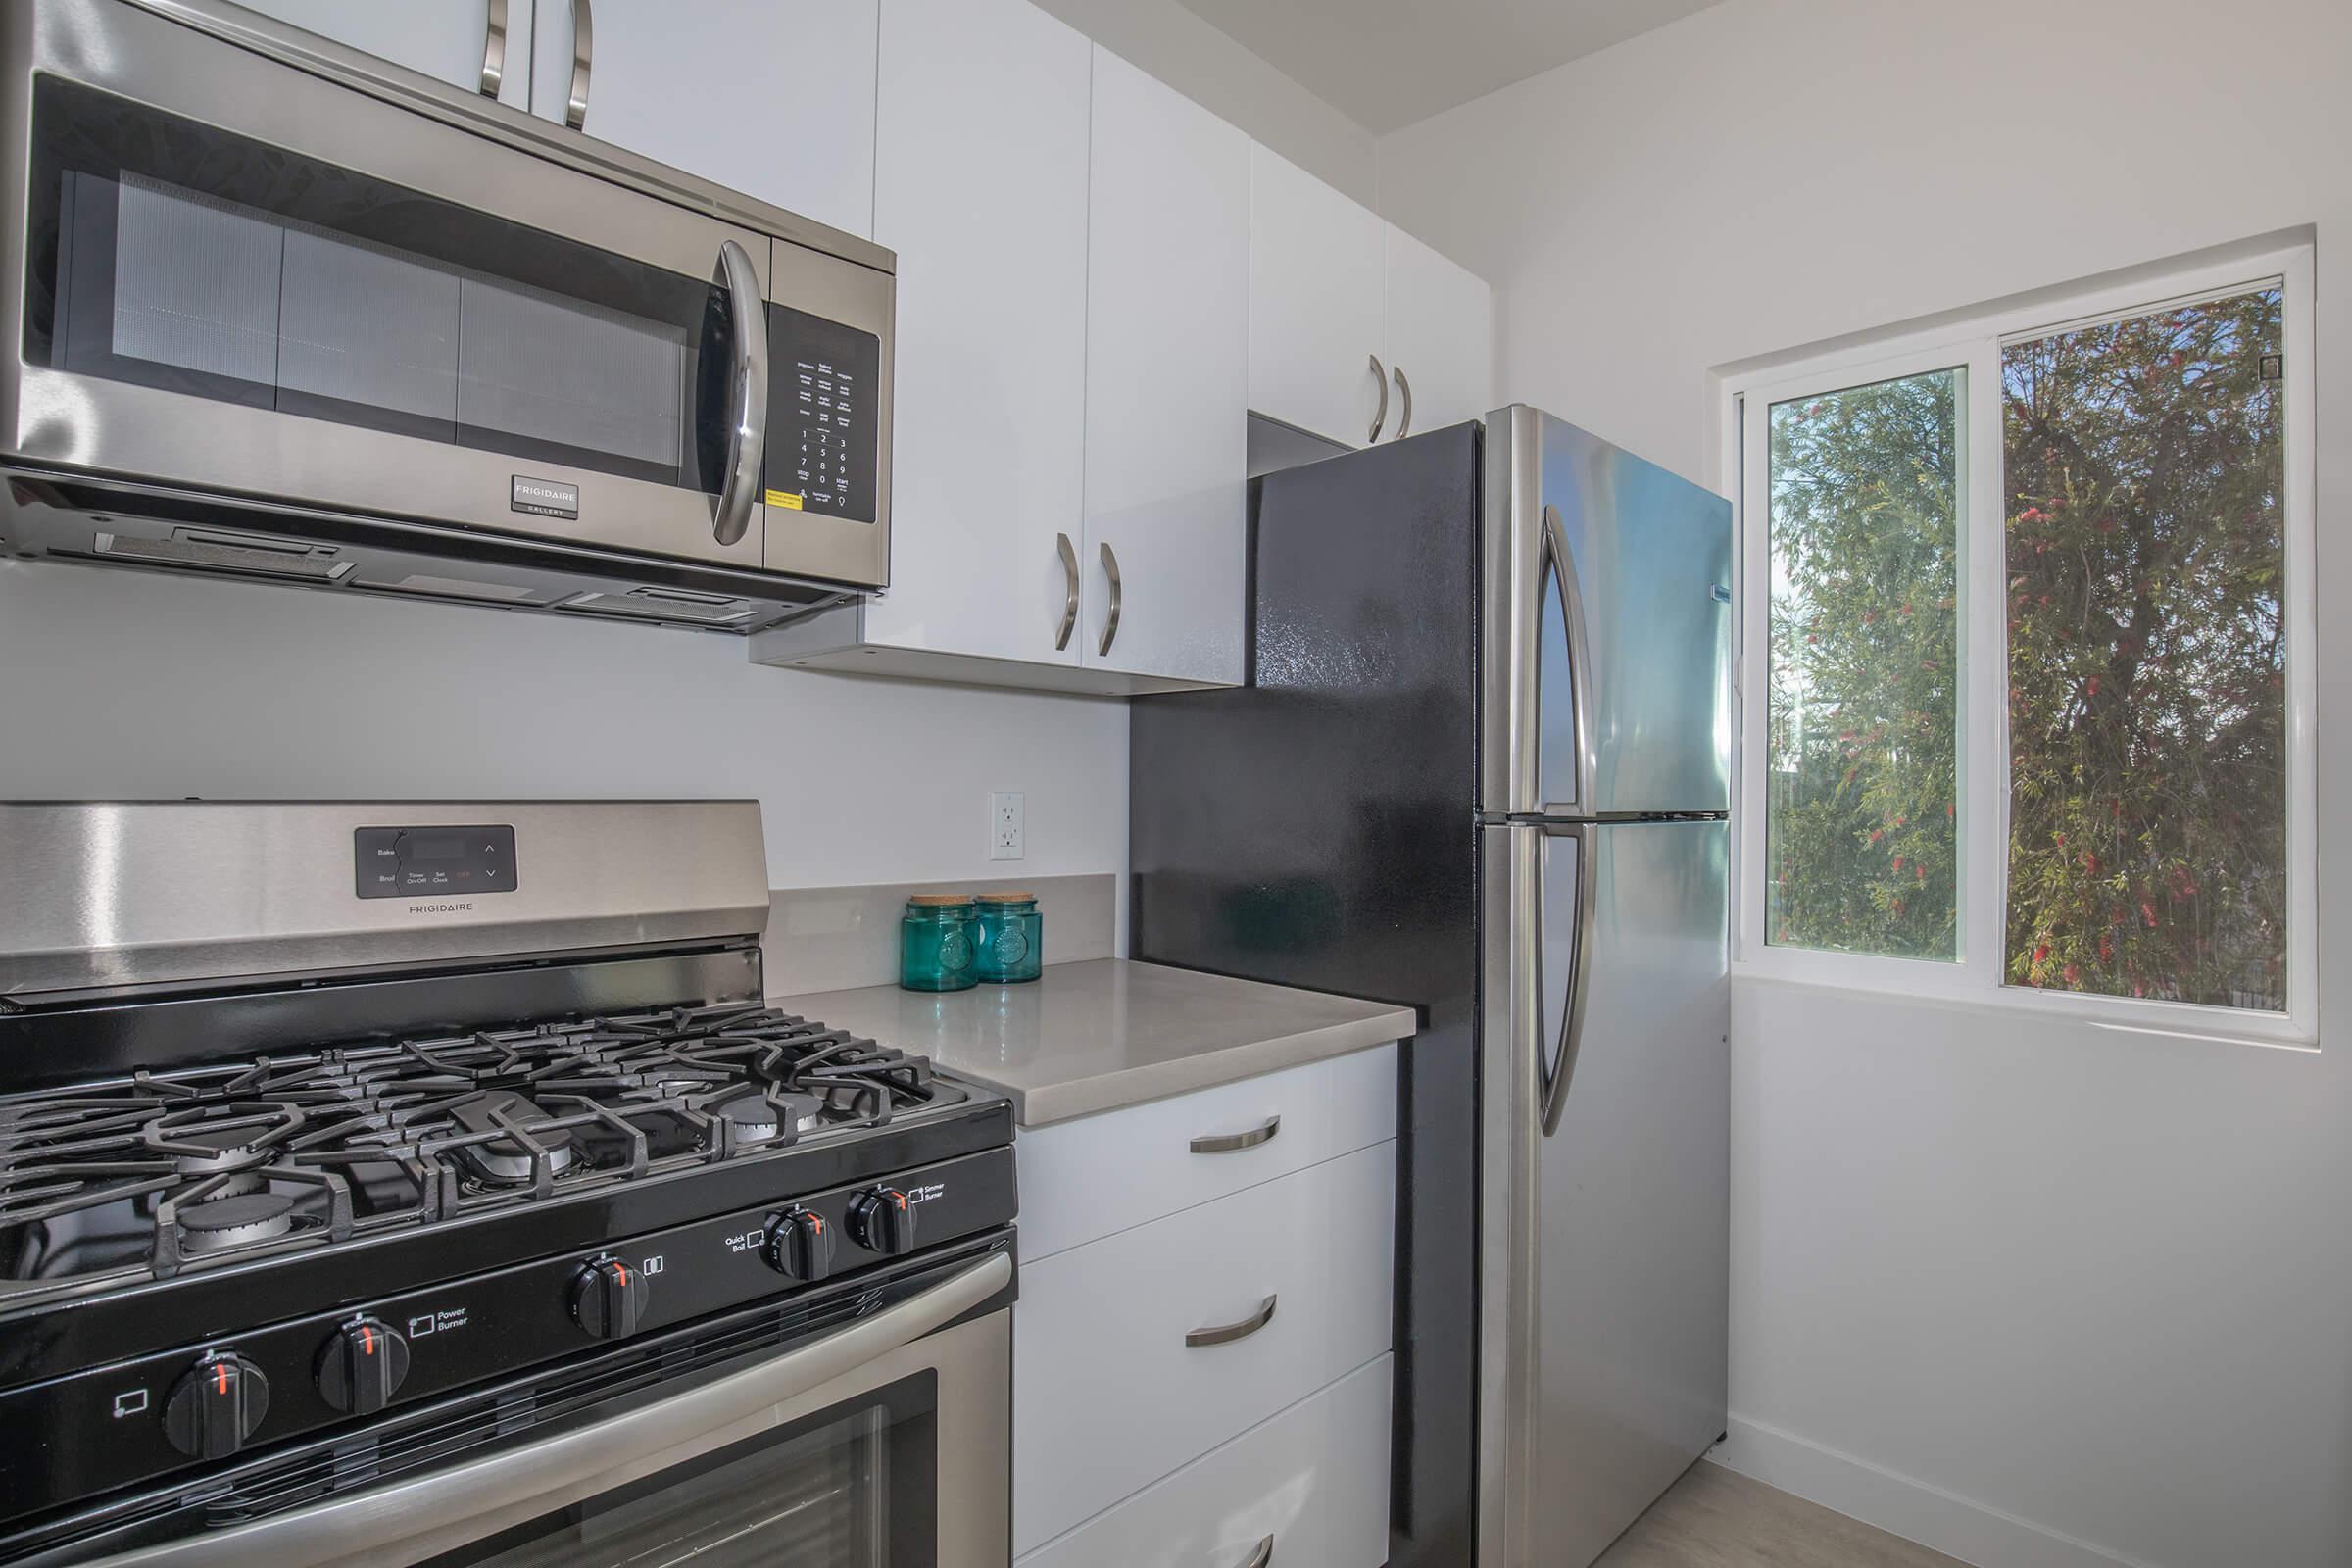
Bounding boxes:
2001 289 2286 1010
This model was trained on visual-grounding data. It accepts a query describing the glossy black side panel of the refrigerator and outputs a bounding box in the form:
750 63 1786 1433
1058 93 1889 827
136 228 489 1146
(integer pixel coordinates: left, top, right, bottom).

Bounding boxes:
1129 425 1482 1568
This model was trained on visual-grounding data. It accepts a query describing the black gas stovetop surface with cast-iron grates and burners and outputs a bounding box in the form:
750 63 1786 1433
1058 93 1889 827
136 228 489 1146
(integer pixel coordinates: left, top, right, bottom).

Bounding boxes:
0 1004 971 1307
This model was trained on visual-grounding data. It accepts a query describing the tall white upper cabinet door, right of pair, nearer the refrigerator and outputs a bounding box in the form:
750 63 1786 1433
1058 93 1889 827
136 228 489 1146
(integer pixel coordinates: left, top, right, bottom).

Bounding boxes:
1084 49 1249 684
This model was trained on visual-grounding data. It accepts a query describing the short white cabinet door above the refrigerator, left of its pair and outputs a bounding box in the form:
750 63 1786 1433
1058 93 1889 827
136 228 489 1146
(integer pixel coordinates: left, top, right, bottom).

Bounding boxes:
1249 146 1393 447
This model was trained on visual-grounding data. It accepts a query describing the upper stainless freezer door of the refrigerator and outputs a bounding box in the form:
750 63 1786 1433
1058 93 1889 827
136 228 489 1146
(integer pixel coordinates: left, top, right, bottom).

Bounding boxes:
1480 407 1731 818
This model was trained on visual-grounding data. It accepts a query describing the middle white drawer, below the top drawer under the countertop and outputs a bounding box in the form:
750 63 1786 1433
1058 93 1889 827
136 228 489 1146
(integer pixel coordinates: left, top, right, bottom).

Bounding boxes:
1013 1143 1397 1551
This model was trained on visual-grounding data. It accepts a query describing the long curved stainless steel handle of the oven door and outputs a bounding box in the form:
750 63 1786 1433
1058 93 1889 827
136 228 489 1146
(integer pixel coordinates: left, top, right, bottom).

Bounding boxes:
77 1253 1013 1568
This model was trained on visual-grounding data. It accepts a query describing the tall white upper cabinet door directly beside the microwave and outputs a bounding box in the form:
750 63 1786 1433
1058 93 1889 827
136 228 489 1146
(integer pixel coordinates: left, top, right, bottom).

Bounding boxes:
865 0 1092 665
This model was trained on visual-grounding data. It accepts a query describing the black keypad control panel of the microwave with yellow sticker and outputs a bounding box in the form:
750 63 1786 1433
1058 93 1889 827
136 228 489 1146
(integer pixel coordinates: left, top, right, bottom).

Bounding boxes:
766 306 882 522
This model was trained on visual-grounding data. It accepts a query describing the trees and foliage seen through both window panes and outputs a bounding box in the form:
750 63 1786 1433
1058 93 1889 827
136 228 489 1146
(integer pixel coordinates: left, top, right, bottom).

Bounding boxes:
1764 289 2288 1010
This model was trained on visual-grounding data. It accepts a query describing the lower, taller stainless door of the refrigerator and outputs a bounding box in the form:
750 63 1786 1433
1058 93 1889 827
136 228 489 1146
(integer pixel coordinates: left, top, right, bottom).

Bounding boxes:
1477 823 1731 1568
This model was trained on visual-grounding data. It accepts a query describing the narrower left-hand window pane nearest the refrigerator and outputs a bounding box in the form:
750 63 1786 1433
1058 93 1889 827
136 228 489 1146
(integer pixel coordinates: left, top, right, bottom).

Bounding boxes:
1764 369 1966 961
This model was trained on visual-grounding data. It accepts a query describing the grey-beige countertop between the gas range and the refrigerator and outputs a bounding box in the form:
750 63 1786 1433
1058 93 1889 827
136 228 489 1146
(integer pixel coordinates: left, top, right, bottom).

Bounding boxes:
774 959 1416 1126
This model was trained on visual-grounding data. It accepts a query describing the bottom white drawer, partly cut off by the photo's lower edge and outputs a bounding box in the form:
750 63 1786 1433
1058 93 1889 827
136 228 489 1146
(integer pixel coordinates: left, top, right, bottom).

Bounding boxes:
1018 1356 1395 1568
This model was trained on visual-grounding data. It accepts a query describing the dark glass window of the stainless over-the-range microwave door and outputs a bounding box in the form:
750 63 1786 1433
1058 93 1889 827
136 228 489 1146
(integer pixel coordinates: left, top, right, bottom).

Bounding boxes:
24 75 734 494
